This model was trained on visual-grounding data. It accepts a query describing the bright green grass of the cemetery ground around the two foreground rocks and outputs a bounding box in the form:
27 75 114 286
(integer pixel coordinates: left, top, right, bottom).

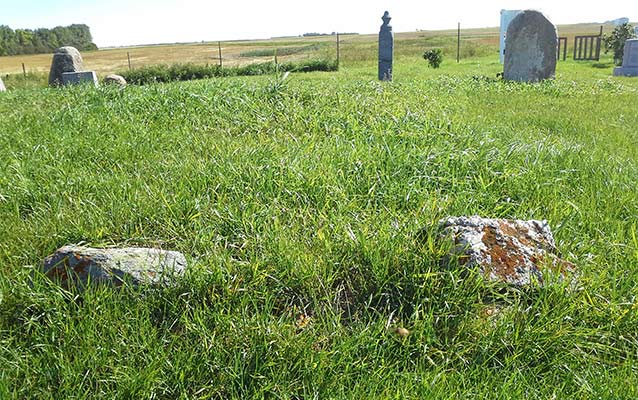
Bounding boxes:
0 30 638 399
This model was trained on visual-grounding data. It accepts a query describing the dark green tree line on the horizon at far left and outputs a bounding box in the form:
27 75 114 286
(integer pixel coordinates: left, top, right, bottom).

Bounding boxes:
0 24 97 56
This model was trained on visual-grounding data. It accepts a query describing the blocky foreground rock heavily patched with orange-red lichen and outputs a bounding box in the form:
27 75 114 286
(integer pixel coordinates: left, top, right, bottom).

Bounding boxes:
440 216 575 286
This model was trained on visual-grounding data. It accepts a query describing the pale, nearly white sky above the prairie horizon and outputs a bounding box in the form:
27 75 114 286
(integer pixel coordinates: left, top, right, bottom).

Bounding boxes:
0 0 638 47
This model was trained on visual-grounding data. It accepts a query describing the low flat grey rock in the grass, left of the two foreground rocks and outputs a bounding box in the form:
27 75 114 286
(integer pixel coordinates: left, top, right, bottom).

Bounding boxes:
42 245 186 289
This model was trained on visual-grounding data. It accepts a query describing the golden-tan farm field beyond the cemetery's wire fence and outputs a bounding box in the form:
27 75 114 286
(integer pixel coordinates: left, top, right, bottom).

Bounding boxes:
0 24 632 76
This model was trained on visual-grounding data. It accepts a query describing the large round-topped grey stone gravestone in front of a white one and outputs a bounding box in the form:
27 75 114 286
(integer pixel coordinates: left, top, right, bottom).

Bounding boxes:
503 10 558 82
